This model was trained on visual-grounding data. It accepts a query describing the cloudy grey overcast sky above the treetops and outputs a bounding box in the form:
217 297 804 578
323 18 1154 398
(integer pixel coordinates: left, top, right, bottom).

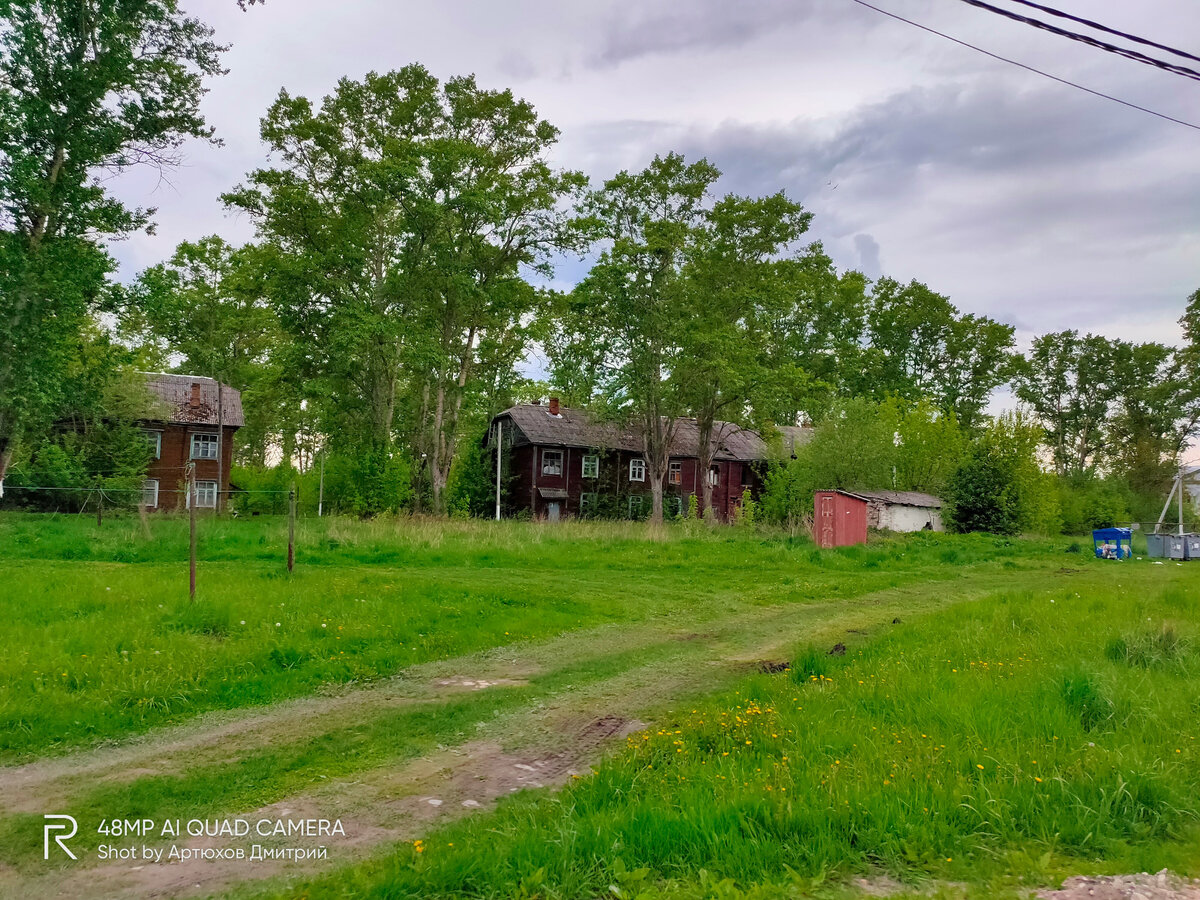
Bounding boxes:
114 0 1200 355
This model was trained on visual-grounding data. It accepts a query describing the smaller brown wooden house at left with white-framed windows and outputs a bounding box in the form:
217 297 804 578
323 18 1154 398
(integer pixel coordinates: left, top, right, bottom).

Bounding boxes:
142 374 246 510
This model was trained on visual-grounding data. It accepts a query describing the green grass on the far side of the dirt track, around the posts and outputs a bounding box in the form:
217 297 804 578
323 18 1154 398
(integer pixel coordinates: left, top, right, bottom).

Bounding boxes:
0 514 1075 763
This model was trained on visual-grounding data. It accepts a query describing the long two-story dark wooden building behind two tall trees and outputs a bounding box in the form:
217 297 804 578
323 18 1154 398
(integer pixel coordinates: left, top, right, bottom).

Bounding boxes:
485 397 811 521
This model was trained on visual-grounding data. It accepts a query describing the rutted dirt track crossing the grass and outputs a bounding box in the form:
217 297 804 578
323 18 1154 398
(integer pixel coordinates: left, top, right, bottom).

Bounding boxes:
0 574 1060 899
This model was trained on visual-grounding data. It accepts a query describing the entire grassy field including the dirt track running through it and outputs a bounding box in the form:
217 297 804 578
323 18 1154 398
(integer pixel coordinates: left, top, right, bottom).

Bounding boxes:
0 515 1200 900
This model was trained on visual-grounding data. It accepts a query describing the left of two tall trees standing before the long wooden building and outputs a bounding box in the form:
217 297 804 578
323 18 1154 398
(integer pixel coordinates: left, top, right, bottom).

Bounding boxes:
552 154 720 523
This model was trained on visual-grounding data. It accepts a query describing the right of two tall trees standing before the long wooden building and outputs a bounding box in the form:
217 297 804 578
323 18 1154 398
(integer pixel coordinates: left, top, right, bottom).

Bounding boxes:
676 193 812 514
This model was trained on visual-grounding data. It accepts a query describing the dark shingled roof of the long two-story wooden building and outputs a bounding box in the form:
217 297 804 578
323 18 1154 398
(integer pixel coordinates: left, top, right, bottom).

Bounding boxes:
496 403 812 462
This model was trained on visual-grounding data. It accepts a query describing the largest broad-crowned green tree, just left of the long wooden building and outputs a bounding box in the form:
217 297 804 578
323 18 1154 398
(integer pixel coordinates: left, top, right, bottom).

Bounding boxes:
226 65 586 511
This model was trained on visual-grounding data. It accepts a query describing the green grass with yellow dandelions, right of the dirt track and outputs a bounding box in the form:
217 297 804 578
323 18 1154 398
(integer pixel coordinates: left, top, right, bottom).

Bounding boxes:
255 573 1200 900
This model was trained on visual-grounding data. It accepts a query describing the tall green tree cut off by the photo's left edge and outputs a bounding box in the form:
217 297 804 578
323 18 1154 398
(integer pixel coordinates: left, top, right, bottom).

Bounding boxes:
0 0 222 494
